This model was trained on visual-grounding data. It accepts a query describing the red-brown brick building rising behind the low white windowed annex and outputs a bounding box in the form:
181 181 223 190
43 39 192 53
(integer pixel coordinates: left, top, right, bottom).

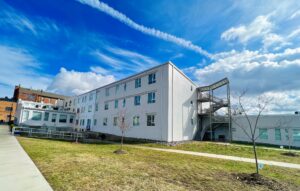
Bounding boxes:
13 86 68 104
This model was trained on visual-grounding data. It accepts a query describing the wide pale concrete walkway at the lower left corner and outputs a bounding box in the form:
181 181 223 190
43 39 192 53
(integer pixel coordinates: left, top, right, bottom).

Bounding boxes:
0 125 52 191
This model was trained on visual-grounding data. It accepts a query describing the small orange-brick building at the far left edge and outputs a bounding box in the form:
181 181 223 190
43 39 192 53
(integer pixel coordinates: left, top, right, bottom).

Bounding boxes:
0 98 17 123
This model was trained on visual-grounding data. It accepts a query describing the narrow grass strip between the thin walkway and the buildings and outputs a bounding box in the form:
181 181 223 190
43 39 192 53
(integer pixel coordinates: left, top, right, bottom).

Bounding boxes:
143 141 300 164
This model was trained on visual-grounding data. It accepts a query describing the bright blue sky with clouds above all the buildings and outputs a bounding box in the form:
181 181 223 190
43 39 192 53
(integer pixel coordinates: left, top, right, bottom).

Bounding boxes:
0 0 300 112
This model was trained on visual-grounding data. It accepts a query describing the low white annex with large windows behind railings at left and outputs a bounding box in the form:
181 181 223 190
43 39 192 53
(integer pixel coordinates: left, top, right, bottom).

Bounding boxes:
15 100 75 128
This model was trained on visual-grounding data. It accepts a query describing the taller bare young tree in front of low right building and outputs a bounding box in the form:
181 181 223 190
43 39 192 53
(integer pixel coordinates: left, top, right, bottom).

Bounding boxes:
232 91 272 174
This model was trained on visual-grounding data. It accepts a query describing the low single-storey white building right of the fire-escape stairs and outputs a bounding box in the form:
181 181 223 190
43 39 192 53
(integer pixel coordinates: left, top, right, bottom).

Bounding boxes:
232 115 300 147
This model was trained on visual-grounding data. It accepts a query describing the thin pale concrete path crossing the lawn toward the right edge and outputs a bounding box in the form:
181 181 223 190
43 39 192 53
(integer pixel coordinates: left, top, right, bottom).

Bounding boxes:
135 145 300 169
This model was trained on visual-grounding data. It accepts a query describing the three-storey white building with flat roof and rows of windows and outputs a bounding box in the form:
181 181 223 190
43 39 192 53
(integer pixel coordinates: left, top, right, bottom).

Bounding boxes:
65 62 197 142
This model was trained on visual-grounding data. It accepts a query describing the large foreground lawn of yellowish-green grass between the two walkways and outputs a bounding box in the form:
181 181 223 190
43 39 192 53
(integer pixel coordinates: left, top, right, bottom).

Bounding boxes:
18 137 300 191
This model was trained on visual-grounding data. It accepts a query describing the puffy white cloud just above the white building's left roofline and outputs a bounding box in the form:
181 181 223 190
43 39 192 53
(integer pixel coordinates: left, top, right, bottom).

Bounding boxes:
47 68 115 95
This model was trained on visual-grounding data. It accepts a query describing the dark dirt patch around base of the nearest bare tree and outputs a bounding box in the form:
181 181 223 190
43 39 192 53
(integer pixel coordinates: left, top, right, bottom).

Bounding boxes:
233 173 290 191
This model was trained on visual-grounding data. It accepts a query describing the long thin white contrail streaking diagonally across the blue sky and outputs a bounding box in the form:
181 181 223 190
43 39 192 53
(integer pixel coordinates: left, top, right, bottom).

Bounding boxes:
78 0 211 57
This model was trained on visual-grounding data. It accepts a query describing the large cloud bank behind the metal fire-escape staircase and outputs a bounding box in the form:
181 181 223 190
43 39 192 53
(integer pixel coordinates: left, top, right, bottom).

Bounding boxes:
188 48 300 113
